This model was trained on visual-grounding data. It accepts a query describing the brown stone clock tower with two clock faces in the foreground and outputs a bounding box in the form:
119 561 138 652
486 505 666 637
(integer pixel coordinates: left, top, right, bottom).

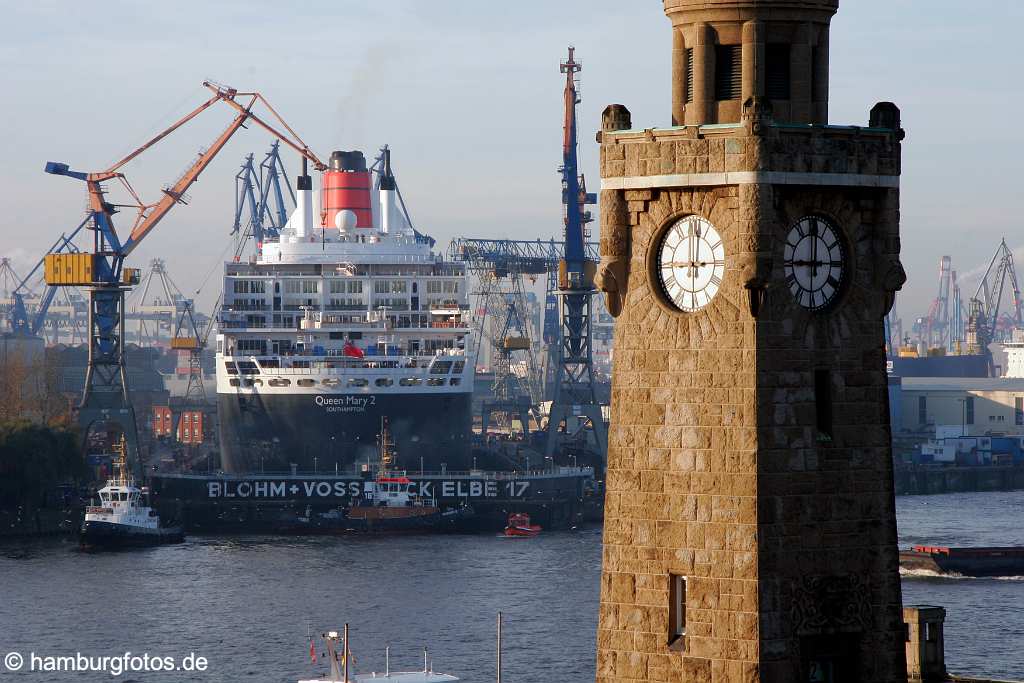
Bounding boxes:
597 0 906 683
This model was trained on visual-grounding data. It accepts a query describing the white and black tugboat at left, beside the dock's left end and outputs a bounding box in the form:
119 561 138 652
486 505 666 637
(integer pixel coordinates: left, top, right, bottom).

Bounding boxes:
80 436 184 550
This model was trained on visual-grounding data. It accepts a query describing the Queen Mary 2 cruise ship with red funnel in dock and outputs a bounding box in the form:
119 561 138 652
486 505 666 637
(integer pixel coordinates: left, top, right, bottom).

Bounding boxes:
217 147 475 473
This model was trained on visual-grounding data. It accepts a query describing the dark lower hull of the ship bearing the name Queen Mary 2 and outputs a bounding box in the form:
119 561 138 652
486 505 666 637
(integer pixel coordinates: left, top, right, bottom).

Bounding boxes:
217 393 472 474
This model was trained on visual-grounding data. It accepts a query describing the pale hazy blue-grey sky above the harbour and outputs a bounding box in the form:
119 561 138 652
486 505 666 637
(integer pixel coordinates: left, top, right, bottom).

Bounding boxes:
0 0 1024 321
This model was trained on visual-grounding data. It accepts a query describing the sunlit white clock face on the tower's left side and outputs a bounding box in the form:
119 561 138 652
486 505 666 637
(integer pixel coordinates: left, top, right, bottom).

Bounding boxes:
657 216 725 312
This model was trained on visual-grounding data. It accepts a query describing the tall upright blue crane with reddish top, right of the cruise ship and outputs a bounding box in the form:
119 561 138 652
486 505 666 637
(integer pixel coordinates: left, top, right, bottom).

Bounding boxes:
545 47 608 458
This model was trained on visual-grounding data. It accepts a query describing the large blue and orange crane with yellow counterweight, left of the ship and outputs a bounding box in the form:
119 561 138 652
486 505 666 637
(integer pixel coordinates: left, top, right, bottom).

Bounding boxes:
46 81 327 466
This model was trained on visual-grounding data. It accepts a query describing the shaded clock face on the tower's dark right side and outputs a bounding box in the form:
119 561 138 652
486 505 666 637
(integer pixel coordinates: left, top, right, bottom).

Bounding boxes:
782 216 846 310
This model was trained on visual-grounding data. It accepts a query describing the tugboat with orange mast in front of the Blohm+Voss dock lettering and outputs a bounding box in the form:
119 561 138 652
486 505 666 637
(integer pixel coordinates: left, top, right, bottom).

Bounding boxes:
280 418 474 533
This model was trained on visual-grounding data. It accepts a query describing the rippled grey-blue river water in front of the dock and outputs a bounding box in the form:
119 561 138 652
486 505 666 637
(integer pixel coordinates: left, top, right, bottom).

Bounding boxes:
0 493 1024 683
